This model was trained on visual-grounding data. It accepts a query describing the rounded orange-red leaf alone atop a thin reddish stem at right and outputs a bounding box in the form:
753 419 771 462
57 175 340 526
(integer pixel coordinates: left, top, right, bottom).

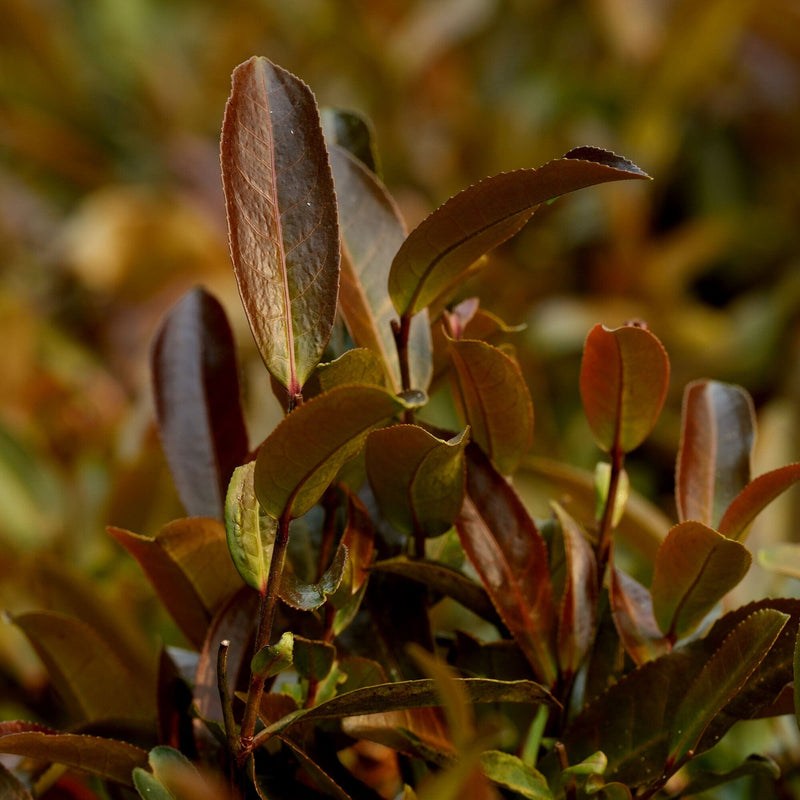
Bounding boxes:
580 325 669 453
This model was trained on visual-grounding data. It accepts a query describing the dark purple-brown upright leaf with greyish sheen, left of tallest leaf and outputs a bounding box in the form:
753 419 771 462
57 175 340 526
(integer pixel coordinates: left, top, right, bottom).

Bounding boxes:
151 288 247 519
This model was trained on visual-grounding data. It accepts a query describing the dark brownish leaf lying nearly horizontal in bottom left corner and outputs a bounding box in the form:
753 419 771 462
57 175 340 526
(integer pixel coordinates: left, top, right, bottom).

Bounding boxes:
0 722 147 786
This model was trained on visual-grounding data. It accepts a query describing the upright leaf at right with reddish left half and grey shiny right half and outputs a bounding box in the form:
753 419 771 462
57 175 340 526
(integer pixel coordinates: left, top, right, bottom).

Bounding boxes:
675 381 755 538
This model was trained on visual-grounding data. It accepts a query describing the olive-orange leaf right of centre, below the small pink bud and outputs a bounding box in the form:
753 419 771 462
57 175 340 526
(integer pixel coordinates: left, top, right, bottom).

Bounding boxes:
450 339 533 475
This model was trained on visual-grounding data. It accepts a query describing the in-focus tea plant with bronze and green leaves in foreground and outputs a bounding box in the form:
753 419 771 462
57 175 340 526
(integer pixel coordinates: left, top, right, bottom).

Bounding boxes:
0 58 800 800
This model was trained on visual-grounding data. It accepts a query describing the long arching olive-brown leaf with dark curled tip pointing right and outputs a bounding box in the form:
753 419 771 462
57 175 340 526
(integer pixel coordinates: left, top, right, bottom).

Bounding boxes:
389 147 647 316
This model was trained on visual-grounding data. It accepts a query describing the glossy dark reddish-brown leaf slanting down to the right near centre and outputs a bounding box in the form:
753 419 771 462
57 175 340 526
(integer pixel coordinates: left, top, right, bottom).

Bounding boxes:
456 448 557 686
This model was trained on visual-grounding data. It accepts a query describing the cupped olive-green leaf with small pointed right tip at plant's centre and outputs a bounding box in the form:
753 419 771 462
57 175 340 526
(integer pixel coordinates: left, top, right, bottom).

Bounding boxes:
366 425 467 536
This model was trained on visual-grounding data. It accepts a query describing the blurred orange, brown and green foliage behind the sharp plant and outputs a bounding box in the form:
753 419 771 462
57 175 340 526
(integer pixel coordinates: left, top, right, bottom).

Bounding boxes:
0 0 800 736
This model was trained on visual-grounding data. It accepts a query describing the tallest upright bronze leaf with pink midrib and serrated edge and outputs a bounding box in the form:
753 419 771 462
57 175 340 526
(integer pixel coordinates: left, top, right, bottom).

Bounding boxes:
220 57 339 397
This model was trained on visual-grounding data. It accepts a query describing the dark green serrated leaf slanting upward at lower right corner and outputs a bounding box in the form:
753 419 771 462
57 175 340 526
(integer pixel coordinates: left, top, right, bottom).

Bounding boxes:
668 609 789 766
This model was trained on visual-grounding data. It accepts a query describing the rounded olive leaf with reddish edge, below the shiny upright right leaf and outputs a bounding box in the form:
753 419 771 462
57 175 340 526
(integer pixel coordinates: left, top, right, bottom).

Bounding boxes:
651 522 752 639
